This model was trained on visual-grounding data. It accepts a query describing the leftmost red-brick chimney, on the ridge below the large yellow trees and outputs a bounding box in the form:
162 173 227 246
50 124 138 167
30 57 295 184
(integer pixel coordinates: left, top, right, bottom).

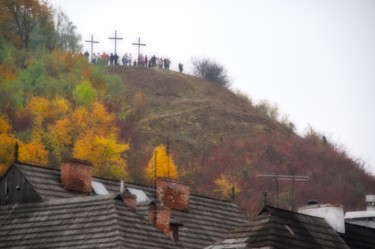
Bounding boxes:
61 159 92 193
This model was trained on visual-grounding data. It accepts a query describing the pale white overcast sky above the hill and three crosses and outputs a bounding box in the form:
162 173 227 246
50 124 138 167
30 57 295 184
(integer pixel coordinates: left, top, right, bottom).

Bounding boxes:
48 0 375 175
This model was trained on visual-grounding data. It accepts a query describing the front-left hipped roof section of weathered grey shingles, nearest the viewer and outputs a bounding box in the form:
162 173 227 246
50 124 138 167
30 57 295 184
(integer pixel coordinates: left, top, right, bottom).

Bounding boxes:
0 195 183 249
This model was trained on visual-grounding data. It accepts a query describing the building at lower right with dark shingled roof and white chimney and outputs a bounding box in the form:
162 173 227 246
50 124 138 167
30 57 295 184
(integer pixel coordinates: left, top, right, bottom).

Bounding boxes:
206 203 375 249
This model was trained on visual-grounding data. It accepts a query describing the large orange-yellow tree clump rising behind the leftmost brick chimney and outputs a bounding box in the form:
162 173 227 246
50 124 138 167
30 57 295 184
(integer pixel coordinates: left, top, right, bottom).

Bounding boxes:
72 102 129 178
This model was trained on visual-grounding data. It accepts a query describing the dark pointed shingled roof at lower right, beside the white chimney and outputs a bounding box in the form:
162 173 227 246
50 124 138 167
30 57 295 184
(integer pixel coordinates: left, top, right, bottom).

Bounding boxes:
206 206 349 249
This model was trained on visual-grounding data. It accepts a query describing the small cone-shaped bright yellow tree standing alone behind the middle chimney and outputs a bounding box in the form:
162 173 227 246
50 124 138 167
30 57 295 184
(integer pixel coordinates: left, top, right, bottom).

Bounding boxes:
146 144 178 181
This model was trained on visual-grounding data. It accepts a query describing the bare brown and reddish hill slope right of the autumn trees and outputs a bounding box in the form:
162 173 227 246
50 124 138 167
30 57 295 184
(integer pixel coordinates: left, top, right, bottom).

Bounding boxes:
109 67 375 215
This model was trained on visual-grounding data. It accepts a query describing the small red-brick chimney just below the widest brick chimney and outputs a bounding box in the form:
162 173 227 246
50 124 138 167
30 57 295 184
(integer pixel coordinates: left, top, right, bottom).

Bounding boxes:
148 202 171 236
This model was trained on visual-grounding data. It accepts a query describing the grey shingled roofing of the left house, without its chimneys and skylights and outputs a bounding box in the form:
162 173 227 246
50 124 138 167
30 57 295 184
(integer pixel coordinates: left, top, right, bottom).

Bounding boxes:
0 163 246 248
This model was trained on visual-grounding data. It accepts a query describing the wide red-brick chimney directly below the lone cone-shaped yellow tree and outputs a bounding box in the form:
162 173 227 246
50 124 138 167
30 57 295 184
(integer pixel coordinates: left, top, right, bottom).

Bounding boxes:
156 178 190 212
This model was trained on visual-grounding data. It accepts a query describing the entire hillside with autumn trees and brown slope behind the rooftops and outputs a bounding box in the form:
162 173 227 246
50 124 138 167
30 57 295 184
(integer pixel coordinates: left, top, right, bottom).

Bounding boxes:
0 0 375 215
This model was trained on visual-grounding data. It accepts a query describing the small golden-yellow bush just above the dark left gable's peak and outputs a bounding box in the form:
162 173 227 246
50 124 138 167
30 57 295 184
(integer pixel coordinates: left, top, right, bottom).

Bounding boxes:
18 141 48 166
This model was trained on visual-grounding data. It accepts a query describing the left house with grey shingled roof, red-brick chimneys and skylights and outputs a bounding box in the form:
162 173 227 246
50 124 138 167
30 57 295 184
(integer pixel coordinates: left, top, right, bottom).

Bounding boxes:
0 160 246 249
